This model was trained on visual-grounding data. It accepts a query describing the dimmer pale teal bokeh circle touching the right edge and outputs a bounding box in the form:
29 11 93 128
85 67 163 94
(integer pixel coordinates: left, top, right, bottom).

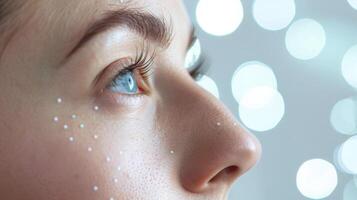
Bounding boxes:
330 98 357 135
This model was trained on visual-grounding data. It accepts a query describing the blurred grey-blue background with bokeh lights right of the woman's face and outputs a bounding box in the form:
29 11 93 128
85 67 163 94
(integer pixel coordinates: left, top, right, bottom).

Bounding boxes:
185 0 357 200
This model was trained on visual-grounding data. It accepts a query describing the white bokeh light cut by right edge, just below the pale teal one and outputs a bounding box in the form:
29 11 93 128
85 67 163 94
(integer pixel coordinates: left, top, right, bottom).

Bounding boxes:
337 136 357 174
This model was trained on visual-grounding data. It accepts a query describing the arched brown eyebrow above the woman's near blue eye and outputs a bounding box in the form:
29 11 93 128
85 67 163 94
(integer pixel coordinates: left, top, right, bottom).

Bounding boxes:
66 8 173 58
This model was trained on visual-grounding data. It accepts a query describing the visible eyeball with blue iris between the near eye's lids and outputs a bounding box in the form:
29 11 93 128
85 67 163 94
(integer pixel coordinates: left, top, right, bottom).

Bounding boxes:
109 70 139 94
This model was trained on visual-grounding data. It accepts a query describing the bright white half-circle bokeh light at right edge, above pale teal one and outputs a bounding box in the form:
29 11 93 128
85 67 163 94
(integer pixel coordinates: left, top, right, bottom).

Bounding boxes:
341 45 357 89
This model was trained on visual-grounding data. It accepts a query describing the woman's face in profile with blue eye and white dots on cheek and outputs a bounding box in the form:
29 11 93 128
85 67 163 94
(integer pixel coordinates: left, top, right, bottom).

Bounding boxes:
0 0 260 200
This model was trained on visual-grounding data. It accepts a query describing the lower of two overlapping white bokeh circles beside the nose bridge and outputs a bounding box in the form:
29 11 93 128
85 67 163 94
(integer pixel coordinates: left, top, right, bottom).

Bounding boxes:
239 86 285 132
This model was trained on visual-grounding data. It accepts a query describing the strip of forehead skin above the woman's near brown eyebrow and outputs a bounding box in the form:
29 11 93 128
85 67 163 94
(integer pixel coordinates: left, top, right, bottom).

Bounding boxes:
37 0 190 38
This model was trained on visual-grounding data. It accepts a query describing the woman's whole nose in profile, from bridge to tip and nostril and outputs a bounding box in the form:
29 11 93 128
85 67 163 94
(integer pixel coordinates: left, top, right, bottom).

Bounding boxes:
159 67 261 193
